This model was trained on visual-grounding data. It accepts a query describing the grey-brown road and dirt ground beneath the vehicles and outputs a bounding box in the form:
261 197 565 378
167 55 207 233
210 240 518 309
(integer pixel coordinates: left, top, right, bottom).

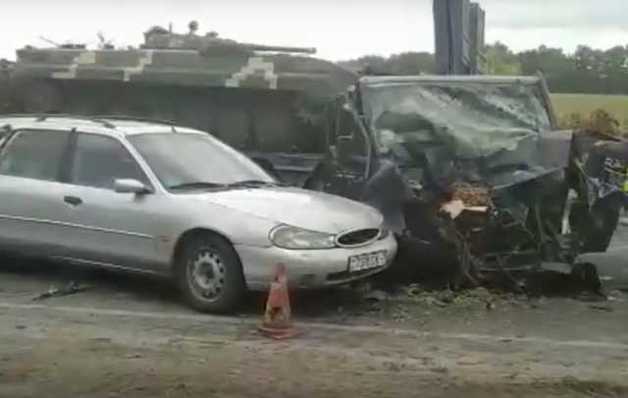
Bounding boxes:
0 228 628 398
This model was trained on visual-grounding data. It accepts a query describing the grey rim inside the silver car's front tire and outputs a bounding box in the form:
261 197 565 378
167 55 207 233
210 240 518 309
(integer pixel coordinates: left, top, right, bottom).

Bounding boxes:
188 249 225 300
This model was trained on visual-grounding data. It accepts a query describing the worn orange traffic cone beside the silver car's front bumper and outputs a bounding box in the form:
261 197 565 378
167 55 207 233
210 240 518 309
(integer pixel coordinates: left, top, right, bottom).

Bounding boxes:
258 264 300 340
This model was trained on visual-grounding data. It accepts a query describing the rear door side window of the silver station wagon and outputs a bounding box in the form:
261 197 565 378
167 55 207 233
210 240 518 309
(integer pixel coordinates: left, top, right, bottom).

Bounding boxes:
0 130 70 181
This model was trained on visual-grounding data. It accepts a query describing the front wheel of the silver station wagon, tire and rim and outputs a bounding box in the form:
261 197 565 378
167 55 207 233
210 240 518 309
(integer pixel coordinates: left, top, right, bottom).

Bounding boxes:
175 234 246 313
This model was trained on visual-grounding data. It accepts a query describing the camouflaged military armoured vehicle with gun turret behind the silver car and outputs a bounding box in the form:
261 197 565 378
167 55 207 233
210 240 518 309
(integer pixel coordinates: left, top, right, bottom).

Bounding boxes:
11 22 357 152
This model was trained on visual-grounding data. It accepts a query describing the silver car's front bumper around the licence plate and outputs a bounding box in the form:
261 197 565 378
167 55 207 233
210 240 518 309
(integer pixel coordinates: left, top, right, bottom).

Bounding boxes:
235 234 397 290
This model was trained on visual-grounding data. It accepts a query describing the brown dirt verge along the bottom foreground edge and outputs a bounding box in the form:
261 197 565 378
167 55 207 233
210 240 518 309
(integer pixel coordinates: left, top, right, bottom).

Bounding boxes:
0 336 628 398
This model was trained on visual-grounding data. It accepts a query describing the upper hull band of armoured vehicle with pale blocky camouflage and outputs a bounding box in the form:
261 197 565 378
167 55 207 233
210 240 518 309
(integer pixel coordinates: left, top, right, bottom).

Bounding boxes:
13 46 357 97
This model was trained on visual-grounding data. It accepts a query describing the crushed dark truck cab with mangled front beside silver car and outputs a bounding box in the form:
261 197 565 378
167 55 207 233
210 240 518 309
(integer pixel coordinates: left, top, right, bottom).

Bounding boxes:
298 76 626 285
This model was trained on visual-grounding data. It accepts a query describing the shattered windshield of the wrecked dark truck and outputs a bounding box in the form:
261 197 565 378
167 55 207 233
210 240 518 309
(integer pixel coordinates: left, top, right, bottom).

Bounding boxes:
364 82 550 158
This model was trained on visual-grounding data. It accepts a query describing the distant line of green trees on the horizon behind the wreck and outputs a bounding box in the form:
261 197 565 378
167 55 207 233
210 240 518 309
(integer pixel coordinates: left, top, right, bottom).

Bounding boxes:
339 42 628 95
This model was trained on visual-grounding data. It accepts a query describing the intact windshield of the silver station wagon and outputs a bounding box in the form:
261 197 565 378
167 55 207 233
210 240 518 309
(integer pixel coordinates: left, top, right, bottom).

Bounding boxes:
129 133 274 190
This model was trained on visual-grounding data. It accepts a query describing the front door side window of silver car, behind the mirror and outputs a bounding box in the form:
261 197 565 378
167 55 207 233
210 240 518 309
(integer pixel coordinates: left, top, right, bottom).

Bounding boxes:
70 133 150 189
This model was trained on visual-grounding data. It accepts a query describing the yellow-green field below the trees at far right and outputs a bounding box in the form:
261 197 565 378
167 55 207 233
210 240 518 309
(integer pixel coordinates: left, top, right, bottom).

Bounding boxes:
552 94 628 129
